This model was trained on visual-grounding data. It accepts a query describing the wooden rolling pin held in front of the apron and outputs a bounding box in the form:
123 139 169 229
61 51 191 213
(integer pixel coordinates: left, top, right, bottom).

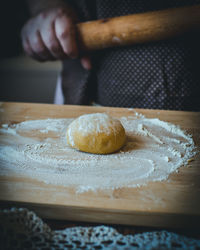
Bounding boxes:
77 5 200 51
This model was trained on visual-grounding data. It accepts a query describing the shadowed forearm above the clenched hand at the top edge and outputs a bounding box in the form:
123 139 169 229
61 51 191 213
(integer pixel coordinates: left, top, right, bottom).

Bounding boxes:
26 0 67 16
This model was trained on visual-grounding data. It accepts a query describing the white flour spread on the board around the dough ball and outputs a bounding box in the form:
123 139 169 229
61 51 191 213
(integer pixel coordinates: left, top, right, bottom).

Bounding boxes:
0 113 196 192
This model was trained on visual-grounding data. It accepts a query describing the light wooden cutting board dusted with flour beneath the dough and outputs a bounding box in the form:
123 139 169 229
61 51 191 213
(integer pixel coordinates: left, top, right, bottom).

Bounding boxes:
0 103 200 228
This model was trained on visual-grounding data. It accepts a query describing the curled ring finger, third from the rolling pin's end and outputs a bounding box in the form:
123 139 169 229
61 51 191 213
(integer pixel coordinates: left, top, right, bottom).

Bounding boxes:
29 31 55 61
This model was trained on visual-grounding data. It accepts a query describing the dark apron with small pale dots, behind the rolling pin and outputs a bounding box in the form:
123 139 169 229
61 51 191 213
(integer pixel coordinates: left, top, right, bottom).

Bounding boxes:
63 0 200 111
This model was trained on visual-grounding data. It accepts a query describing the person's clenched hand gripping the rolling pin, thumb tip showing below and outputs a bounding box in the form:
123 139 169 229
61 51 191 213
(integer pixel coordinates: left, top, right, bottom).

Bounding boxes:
21 7 91 69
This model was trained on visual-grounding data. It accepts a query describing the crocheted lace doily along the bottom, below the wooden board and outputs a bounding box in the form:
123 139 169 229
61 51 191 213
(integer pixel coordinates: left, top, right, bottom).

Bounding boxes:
0 208 200 249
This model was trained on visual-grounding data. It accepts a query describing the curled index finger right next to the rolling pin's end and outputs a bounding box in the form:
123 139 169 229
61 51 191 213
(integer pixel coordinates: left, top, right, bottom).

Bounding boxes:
55 15 78 58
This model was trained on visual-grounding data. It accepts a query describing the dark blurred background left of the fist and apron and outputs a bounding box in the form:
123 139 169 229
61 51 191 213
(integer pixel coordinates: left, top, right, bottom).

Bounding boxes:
0 0 61 103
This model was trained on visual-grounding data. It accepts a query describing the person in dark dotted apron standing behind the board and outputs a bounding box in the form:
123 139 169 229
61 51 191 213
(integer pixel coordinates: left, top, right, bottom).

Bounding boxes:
22 0 200 111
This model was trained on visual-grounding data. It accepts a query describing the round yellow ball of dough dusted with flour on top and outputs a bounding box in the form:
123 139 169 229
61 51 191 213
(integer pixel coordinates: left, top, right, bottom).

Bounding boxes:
67 113 126 154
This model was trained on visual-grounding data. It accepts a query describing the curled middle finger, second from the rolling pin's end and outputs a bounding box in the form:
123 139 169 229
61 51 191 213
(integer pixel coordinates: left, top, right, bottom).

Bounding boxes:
41 22 66 59
